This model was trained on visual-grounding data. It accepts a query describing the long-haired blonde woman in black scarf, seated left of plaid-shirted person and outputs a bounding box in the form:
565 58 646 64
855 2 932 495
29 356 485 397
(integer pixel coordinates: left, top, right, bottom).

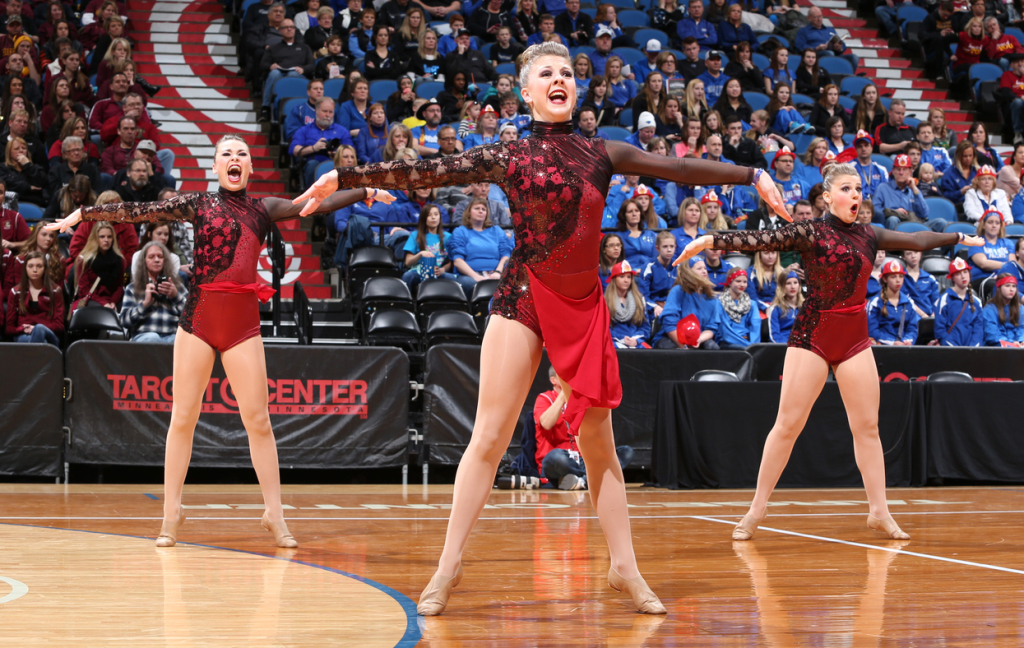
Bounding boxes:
72 221 128 310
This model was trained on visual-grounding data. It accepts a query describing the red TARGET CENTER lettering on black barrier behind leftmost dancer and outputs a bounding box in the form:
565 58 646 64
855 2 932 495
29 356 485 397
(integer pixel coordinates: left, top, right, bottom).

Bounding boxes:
106 374 369 419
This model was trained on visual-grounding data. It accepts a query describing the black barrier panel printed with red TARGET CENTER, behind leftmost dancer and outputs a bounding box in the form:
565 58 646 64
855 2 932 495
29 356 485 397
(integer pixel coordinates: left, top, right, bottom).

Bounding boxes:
66 341 410 468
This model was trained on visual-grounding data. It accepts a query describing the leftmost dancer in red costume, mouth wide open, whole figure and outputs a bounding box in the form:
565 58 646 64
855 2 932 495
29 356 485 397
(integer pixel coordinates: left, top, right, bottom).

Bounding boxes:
49 135 394 548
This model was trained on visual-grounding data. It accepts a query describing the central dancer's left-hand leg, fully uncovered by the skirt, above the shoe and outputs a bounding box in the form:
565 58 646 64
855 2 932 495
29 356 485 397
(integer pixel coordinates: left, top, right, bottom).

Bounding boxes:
437 316 542 577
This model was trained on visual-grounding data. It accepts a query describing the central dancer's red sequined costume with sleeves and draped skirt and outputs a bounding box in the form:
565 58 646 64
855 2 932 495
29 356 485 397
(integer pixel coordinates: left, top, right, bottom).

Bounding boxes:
337 121 753 431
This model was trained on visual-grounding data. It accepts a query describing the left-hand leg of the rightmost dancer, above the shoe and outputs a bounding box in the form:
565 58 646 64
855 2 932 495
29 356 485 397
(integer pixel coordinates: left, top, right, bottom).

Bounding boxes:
746 347 831 520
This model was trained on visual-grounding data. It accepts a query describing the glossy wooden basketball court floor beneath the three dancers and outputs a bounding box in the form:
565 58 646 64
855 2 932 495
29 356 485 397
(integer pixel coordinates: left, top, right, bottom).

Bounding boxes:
0 484 1024 648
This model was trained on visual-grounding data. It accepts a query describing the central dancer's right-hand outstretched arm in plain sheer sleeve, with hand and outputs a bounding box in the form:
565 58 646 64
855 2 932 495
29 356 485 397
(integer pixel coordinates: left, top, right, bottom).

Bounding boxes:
605 141 793 221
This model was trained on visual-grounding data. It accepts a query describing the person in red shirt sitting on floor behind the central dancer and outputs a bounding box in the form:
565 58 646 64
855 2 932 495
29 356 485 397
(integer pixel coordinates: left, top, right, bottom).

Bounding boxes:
534 366 633 490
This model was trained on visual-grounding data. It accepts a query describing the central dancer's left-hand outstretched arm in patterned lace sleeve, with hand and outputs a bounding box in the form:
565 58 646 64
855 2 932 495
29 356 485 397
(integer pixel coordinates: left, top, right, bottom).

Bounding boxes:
293 142 509 216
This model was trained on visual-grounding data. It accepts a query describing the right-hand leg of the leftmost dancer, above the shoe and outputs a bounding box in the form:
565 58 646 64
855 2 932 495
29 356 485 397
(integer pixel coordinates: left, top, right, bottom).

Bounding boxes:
220 336 285 526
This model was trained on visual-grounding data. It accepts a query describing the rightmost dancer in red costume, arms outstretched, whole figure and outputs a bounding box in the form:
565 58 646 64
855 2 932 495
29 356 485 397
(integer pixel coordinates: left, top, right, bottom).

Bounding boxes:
675 164 983 541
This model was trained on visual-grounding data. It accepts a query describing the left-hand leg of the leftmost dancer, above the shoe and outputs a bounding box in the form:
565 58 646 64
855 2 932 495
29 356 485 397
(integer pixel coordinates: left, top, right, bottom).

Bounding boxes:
164 329 216 525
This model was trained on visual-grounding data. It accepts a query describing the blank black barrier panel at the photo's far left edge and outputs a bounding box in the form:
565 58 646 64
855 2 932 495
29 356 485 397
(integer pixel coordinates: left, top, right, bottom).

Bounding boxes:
0 344 63 477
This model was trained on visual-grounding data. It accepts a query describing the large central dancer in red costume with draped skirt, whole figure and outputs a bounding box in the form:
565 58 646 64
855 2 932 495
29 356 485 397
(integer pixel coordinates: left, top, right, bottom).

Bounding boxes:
296 43 785 615
